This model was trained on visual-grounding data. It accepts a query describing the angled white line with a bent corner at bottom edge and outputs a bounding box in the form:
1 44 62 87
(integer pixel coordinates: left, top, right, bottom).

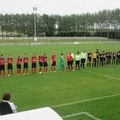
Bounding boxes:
62 112 100 120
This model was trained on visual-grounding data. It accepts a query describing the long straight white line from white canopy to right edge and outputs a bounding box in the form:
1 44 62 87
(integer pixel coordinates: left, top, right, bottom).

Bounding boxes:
51 93 120 108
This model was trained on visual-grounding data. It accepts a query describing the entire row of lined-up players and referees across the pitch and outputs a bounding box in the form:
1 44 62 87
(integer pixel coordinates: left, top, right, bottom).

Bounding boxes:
0 49 120 77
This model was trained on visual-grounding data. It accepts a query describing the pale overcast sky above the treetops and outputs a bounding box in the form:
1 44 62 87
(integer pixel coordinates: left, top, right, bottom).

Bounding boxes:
0 0 120 15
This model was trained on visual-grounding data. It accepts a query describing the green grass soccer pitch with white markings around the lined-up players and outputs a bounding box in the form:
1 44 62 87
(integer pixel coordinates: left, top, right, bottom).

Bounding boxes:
0 43 120 120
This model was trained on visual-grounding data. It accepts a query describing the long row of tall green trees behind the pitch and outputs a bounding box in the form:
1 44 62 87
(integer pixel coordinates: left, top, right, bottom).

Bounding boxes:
0 8 120 39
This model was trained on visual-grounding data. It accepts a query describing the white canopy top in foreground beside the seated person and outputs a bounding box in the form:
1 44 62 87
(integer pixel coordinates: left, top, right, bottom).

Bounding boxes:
0 107 63 120
